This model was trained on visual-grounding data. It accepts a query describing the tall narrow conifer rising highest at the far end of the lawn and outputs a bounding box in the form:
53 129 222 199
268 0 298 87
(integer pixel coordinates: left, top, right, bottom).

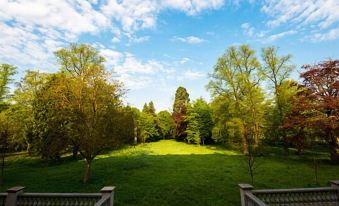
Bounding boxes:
172 87 190 141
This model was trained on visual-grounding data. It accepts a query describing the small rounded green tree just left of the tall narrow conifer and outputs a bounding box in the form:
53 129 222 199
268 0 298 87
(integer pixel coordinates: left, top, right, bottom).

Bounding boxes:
157 111 175 139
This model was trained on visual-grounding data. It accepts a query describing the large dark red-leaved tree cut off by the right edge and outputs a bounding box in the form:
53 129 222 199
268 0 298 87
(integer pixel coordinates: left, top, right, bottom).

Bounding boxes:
300 60 339 163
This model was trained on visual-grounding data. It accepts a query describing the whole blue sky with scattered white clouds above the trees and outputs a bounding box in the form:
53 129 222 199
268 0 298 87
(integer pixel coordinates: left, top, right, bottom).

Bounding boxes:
0 0 339 111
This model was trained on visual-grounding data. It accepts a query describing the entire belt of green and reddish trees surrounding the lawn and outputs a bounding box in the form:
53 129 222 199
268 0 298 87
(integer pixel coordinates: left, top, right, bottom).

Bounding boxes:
0 44 339 182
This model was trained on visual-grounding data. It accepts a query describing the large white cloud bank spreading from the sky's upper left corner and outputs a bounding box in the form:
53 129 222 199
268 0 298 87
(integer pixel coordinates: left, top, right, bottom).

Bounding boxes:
0 0 228 69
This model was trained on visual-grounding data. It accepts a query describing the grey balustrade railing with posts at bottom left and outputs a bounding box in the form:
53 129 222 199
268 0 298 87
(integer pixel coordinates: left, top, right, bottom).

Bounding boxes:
0 187 114 206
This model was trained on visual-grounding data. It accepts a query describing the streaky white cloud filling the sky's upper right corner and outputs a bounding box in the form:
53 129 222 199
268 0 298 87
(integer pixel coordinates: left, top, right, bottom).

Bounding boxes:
261 0 339 41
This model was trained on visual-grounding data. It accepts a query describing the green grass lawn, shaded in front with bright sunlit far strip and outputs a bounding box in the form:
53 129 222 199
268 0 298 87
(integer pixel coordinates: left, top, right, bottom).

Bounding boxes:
1 140 339 206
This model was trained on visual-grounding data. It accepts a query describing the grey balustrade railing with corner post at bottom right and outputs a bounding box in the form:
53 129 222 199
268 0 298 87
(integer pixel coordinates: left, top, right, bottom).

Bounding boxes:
239 181 339 206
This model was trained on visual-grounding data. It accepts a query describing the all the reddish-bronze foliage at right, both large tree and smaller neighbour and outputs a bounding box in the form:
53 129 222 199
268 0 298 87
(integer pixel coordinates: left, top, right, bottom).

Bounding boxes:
284 60 339 163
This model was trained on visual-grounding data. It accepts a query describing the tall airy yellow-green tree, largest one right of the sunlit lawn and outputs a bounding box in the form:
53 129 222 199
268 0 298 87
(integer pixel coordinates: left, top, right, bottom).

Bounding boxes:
208 45 265 153
